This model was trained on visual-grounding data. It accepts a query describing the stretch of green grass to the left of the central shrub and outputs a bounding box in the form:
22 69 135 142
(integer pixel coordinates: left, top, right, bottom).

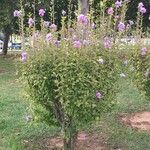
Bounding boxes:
0 58 56 150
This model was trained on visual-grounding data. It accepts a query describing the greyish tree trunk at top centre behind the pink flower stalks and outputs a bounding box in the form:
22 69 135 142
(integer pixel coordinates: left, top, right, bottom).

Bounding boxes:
80 0 89 15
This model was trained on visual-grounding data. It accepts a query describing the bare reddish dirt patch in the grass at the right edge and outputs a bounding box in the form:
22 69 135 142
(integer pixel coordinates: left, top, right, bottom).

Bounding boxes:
120 111 150 131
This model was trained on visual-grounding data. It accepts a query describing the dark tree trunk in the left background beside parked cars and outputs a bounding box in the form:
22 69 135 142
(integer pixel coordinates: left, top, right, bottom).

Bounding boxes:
2 25 11 55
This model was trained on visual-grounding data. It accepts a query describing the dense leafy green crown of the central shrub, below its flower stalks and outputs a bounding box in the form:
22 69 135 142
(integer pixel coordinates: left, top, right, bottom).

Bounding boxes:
21 32 118 149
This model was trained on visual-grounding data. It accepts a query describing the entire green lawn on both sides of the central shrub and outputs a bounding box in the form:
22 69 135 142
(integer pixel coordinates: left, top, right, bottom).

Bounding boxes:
0 57 150 150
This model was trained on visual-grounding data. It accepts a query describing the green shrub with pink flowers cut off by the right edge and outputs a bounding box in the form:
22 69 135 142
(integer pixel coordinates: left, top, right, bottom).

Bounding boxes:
131 47 150 100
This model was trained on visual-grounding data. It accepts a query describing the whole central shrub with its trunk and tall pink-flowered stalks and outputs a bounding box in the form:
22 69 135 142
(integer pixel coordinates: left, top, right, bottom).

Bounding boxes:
17 1 124 150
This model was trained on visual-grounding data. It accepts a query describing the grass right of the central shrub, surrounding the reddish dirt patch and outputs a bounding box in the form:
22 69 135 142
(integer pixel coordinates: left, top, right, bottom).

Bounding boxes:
97 80 150 150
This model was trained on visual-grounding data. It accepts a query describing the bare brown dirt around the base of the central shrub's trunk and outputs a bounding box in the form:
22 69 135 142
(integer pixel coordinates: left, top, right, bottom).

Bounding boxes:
23 132 107 150
